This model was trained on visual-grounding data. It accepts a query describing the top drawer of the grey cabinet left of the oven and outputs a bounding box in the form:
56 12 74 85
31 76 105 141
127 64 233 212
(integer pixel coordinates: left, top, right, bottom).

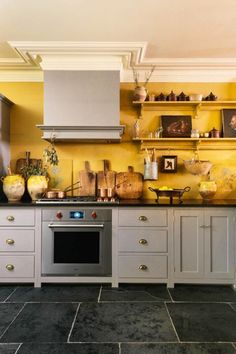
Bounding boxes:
0 208 35 226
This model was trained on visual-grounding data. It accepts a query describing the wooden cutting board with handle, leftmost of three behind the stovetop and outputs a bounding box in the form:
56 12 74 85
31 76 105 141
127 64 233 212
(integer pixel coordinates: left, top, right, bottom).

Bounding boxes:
78 161 96 197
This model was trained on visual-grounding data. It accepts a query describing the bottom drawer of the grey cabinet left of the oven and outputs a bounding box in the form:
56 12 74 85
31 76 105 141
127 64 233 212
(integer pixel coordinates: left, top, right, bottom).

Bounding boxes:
0 256 34 278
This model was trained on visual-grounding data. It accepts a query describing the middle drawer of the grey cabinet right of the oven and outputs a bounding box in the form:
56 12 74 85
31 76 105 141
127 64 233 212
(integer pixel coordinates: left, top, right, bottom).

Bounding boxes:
119 228 168 252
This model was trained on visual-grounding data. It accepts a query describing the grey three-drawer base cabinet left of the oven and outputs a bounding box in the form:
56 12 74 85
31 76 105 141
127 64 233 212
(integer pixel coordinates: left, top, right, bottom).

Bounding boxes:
0 207 37 284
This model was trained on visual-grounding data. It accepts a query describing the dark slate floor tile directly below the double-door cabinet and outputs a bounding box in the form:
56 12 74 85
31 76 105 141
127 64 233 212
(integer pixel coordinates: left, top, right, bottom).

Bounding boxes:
169 285 236 302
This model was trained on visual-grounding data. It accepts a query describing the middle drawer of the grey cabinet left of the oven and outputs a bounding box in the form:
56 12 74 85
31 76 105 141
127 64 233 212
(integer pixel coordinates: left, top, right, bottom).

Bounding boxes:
0 229 34 253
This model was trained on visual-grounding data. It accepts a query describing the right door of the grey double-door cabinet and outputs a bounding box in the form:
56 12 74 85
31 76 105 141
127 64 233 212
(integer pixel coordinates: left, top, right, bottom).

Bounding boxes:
204 209 235 279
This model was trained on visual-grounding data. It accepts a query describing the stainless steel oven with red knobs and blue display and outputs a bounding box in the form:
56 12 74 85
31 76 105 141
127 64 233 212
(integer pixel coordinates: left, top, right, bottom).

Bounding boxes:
42 206 112 276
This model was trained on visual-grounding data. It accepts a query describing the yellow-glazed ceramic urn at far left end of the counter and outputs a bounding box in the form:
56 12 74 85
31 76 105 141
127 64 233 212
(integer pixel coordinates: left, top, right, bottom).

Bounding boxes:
1 175 25 202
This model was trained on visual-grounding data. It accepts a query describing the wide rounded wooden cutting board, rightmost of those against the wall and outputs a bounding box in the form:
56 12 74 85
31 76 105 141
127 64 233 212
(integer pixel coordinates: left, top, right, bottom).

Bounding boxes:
116 166 143 199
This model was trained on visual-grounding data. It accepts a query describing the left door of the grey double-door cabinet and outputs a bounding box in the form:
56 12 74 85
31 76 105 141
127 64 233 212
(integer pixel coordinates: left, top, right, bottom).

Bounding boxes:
174 210 204 279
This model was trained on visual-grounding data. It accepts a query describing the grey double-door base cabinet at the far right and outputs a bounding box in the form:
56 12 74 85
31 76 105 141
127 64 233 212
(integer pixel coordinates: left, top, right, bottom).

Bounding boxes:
173 208 235 283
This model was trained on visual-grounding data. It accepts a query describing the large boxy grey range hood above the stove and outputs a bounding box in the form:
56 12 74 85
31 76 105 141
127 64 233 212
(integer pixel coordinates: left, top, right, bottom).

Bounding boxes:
37 70 124 142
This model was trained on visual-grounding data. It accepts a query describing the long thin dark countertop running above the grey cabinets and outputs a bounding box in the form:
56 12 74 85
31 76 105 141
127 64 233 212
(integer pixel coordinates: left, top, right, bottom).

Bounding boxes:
0 198 236 208
